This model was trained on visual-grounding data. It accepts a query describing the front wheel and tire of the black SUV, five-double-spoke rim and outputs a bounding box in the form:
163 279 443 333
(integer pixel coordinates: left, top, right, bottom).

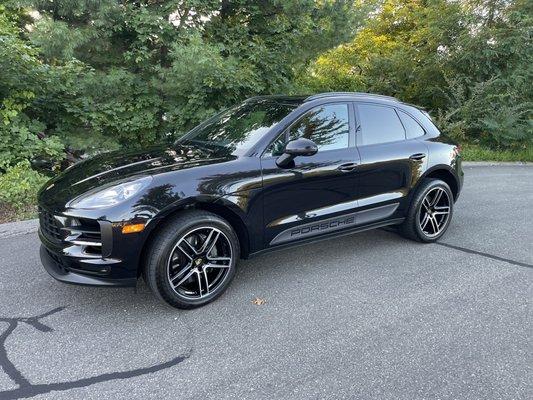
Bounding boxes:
143 210 240 309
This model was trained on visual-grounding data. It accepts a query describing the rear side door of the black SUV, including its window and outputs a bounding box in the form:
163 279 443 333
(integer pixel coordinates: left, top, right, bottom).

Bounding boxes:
356 102 428 219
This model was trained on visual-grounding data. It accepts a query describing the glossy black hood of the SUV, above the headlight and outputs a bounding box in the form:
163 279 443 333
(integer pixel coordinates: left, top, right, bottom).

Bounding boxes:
38 146 235 210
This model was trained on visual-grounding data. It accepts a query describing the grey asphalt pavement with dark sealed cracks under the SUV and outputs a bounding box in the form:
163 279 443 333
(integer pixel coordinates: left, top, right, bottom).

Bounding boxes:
0 166 533 400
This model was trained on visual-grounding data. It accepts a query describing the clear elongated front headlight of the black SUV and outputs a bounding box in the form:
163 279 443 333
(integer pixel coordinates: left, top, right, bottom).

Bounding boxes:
68 176 152 209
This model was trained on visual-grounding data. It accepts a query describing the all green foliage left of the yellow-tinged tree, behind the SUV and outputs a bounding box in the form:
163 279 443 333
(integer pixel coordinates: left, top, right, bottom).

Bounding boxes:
0 0 362 219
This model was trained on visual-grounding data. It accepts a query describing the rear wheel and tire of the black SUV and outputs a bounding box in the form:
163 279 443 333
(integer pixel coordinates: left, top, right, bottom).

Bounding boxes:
399 179 454 243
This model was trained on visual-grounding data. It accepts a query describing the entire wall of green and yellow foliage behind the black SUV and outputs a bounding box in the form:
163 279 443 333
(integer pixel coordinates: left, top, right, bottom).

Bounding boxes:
0 0 533 218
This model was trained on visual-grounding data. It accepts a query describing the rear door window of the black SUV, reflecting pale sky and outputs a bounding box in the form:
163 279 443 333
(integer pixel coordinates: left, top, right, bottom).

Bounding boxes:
357 104 405 145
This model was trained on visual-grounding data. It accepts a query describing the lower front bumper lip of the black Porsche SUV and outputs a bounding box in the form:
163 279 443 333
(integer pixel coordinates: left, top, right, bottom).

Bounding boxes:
40 244 137 286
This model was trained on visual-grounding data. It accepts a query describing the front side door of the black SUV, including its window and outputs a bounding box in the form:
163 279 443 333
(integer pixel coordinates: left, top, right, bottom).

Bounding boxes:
261 103 359 247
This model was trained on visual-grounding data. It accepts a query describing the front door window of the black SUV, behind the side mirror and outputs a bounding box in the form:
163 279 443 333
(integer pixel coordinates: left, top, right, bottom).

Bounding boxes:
267 104 350 156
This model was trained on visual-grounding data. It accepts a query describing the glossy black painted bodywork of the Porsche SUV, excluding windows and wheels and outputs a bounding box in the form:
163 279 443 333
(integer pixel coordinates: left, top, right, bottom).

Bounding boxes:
39 94 463 286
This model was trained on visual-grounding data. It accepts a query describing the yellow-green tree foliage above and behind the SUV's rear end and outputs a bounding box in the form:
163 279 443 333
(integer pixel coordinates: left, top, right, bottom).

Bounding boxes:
301 0 533 149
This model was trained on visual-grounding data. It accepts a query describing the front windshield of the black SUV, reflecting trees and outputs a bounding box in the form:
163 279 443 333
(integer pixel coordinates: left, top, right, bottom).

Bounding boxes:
176 99 297 155
